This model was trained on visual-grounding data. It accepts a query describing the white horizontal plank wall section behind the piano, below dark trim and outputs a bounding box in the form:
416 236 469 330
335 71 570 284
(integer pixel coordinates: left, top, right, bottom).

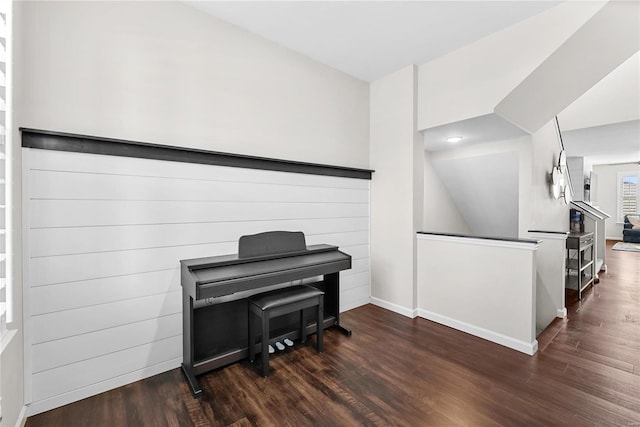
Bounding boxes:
23 148 370 413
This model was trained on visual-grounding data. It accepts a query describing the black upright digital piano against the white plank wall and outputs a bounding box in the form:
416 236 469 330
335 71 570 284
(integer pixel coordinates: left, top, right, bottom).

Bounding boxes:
180 231 351 396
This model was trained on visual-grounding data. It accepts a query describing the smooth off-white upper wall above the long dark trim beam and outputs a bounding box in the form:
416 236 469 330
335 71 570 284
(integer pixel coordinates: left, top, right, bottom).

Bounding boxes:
20 1 369 168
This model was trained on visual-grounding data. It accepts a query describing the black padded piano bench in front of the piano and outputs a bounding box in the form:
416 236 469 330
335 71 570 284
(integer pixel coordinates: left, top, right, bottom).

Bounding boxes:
249 285 324 377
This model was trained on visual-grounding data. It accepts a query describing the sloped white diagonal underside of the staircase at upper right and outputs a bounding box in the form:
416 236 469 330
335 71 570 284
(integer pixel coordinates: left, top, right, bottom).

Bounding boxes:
494 1 640 133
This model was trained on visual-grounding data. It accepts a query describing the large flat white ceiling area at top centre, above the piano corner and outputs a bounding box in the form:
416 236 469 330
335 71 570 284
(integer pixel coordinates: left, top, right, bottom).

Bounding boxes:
186 1 560 82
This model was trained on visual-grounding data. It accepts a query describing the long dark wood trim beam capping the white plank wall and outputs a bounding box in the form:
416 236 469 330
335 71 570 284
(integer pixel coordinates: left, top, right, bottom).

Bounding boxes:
20 128 373 179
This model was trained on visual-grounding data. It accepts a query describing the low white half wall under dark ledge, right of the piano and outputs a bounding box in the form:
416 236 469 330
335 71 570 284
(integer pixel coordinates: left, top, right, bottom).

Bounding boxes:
417 235 538 354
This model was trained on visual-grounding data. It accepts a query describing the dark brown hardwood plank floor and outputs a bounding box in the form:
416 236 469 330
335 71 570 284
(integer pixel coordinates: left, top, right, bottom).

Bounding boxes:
26 242 640 427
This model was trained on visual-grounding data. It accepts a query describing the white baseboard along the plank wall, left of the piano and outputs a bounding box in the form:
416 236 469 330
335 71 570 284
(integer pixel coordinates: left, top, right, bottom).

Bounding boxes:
27 358 182 416
